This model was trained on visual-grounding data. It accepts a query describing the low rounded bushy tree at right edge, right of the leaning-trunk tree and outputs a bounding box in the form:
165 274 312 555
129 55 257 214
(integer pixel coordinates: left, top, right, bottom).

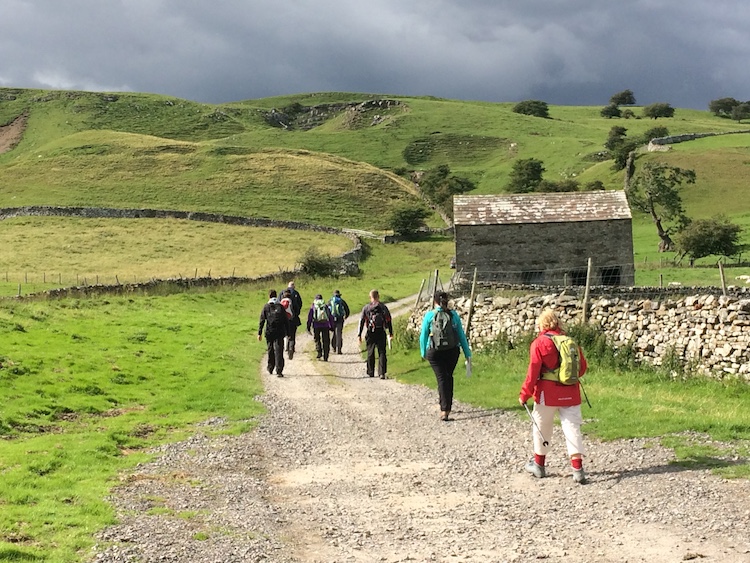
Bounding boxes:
675 215 742 266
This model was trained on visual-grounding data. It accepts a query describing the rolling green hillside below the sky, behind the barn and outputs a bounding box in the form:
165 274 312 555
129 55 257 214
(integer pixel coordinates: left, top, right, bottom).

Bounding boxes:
0 88 750 241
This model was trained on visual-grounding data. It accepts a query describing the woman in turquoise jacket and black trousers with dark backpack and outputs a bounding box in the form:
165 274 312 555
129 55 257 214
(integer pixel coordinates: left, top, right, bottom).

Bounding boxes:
419 291 471 422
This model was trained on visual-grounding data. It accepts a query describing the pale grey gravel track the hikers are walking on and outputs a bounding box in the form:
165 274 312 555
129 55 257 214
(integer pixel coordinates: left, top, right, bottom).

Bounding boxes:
90 300 750 563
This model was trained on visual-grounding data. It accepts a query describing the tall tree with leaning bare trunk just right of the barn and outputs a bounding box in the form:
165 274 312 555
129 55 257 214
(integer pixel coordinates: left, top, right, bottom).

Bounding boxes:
625 162 695 252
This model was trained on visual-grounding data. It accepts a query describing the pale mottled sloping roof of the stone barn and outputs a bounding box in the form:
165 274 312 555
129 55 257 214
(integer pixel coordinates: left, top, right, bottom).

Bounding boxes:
453 191 632 225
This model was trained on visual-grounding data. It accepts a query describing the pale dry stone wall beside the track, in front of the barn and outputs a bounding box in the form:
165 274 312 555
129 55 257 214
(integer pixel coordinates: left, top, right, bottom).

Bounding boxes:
409 288 750 381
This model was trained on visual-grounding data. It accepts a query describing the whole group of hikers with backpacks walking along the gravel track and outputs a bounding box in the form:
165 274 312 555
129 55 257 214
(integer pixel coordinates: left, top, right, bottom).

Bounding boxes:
258 281 588 484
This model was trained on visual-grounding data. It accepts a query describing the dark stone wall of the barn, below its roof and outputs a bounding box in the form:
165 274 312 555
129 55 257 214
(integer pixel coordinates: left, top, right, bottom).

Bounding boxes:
455 219 635 285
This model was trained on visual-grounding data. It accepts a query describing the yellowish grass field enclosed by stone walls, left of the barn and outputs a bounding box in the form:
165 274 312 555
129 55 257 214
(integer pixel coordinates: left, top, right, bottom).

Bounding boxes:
0 217 354 295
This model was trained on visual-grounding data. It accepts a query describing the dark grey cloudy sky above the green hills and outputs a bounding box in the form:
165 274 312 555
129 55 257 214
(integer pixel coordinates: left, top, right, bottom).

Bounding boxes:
0 0 750 110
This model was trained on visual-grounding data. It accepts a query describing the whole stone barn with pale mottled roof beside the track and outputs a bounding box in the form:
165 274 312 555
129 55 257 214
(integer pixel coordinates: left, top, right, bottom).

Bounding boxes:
453 191 635 286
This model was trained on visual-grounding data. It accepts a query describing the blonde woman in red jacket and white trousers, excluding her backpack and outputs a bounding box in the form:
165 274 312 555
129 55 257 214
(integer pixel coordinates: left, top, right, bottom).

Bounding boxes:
518 309 588 483
